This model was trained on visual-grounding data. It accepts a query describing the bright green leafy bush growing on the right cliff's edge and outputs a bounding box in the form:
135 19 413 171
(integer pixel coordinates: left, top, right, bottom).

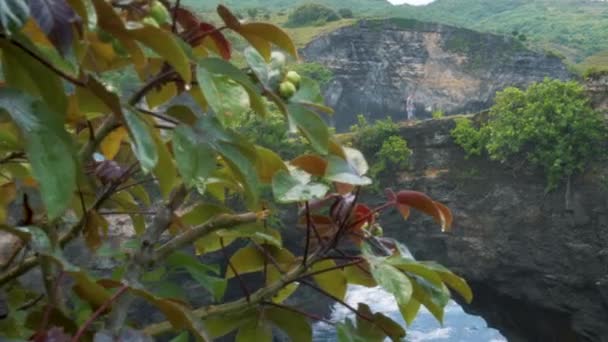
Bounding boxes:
452 79 608 189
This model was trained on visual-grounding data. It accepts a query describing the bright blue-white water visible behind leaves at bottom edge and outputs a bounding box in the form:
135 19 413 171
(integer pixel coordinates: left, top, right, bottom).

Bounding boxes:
313 285 507 342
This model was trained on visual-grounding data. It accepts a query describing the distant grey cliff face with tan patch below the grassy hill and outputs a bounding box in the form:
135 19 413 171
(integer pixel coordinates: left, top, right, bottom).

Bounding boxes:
302 19 571 130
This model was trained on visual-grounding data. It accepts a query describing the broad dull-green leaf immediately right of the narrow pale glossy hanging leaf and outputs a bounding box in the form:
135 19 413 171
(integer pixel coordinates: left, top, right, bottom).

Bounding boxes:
173 125 216 187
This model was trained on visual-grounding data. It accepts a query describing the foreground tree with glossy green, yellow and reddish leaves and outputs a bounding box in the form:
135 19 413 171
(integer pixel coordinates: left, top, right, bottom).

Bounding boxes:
0 0 472 341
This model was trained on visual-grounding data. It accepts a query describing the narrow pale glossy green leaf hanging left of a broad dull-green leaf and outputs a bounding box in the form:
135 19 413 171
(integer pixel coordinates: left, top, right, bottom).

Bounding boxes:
124 110 158 172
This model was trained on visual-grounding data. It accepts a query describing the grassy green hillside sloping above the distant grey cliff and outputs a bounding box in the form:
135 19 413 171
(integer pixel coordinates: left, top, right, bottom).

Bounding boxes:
183 0 608 63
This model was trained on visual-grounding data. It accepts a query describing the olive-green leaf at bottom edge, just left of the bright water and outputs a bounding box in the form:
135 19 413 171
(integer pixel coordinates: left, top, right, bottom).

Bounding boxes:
264 307 312 342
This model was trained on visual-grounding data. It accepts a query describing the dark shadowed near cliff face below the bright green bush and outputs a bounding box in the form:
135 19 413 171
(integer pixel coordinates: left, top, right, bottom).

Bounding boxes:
376 119 608 342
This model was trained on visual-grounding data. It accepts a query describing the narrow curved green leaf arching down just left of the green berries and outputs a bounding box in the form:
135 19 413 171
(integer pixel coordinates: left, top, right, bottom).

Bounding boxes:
199 58 267 116
